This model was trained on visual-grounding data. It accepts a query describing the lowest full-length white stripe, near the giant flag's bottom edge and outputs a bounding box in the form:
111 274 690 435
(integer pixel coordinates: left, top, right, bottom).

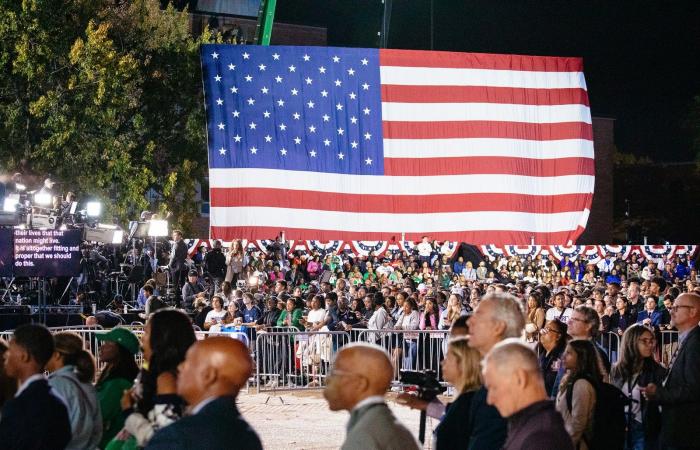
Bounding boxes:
210 206 582 233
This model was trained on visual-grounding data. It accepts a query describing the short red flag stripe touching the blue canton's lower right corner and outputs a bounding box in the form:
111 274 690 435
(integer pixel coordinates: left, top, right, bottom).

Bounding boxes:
384 157 595 177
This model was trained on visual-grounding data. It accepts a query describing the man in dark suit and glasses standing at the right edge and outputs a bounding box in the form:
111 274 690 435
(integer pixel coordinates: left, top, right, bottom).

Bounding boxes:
642 294 700 450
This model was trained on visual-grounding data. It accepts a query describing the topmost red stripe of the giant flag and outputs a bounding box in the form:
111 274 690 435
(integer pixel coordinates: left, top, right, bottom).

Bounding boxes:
379 49 583 72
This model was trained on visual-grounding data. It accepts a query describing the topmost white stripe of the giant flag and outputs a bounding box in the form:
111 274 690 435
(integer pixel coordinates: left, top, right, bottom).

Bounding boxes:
379 66 586 89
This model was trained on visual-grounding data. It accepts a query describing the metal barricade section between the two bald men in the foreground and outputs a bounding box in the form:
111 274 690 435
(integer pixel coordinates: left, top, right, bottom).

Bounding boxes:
254 331 350 392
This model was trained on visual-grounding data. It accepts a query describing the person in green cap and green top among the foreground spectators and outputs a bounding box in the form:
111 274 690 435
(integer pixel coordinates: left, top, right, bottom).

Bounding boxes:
95 327 140 448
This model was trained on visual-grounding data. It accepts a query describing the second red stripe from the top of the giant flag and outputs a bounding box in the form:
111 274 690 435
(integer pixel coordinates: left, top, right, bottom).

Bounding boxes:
382 84 589 106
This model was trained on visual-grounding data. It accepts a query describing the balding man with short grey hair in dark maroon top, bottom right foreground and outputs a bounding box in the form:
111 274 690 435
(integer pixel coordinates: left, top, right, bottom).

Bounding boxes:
482 339 574 450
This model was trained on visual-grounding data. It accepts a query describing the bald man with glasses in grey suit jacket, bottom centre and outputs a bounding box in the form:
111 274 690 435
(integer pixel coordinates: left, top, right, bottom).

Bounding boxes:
323 344 418 450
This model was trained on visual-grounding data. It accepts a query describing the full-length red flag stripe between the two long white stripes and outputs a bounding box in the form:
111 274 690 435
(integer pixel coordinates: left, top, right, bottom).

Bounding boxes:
210 186 592 214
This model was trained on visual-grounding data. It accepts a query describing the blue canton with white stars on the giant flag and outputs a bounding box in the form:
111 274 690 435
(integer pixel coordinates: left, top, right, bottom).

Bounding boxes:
201 45 384 175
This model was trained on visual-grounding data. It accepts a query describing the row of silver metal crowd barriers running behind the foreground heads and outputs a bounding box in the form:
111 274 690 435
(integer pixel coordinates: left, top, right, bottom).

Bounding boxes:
0 326 678 392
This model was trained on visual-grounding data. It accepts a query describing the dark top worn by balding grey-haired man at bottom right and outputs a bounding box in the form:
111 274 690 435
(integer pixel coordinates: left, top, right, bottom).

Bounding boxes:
503 400 574 450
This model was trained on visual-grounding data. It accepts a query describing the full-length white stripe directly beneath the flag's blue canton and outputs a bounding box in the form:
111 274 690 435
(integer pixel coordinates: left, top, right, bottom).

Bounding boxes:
209 169 595 195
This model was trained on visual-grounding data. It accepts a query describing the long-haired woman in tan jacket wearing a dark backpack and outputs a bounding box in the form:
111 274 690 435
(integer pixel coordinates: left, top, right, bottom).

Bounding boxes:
556 339 603 450
